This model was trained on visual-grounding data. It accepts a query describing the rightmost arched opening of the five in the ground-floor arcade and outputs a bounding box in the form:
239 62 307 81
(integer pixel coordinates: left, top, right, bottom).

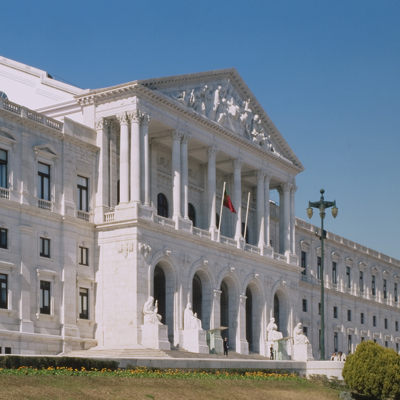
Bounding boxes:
270 281 292 337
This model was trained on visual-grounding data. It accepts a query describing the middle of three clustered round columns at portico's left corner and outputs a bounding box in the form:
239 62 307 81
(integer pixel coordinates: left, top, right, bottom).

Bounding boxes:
128 110 143 203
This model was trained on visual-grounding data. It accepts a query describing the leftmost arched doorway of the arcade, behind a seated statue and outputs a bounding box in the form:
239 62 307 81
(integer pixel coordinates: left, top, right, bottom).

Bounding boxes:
153 264 175 343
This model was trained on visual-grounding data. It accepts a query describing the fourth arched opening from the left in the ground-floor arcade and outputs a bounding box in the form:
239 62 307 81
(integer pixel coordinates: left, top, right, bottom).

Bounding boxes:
244 278 265 353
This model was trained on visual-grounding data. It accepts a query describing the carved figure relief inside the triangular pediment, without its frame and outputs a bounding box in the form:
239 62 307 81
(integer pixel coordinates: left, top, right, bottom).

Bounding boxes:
156 83 278 154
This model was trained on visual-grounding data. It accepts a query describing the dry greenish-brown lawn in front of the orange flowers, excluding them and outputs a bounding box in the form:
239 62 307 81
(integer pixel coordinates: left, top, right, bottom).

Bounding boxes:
0 374 346 400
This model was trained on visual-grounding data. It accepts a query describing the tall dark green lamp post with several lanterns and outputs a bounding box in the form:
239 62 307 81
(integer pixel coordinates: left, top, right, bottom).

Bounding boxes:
307 189 338 360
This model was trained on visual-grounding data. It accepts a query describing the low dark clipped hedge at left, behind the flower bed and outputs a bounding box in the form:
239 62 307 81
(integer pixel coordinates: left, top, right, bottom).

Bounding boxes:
0 356 118 371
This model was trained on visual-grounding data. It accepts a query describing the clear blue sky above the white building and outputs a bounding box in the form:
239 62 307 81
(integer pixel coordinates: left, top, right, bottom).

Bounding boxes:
0 0 400 259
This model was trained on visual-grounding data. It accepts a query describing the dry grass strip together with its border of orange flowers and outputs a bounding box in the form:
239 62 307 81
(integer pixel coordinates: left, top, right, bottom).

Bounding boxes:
0 367 343 400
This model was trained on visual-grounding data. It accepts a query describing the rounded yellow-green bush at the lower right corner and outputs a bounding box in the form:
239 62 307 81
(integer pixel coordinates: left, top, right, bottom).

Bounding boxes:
342 341 400 399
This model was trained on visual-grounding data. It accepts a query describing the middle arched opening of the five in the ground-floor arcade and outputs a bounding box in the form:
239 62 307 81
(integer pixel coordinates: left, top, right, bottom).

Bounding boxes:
219 273 239 350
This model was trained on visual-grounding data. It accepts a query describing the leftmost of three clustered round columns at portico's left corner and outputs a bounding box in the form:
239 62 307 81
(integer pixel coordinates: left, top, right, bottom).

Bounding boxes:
117 112 129 203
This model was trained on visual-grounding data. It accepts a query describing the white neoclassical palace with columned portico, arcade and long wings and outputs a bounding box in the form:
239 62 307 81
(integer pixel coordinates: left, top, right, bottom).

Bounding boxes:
0 58 400 358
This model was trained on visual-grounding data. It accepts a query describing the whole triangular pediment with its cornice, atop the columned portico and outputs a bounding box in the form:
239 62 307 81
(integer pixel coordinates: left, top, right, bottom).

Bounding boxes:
137 69 304 170
